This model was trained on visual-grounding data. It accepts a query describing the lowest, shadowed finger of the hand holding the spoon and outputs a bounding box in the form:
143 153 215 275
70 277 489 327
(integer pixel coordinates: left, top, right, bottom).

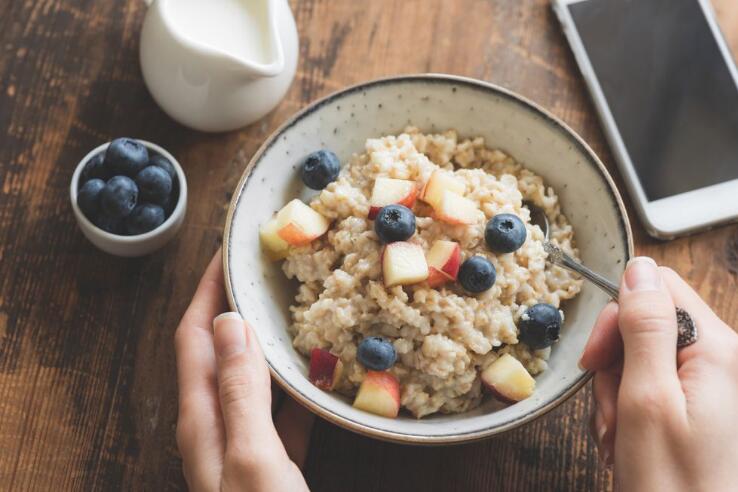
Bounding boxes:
592 368 620 465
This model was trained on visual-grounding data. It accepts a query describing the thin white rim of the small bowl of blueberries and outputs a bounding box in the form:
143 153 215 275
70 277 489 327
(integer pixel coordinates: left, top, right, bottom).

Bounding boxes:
69 138 187 244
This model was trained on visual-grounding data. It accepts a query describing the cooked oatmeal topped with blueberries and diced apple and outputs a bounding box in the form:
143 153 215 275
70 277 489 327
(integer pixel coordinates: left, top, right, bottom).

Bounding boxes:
261 128 581 418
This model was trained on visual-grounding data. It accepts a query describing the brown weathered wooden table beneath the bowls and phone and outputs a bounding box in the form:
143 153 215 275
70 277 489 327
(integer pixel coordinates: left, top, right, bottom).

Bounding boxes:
0 0 738 491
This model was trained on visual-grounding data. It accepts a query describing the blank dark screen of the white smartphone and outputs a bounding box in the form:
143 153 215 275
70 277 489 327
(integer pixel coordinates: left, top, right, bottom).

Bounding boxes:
569 0 738 201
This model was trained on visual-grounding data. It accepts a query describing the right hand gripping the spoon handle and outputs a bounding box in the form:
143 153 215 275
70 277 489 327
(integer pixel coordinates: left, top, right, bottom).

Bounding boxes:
580 258 738 491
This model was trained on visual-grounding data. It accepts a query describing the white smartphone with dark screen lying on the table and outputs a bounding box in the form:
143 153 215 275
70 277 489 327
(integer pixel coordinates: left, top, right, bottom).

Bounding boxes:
553 0 738 239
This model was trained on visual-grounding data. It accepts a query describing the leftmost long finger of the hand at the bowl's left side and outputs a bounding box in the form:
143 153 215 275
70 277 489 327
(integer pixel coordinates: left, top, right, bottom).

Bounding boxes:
175 252 225 490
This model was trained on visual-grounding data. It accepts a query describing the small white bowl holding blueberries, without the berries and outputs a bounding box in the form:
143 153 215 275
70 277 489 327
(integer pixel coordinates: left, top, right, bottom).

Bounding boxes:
69 139 187 257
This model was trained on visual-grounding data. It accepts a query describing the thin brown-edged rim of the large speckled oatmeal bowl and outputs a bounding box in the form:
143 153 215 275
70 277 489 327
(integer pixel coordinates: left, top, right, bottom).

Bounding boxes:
223 73 634 445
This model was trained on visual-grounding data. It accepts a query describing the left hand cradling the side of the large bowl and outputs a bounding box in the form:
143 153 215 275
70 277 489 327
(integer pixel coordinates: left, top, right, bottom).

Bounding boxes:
175 251 312 492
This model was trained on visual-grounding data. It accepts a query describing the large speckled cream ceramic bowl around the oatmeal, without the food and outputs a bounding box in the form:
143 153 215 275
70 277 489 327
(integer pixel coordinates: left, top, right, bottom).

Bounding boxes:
224 75 633 444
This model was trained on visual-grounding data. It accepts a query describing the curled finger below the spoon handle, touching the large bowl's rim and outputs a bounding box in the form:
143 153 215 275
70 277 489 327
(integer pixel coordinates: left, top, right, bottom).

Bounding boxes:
579 302 623 371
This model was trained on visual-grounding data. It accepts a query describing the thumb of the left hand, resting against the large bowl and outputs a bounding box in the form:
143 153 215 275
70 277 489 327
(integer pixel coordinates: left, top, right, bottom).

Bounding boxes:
213 313 286 466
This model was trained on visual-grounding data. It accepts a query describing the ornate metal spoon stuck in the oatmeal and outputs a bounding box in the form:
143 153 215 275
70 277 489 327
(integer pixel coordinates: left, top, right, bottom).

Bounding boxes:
523 202 697 348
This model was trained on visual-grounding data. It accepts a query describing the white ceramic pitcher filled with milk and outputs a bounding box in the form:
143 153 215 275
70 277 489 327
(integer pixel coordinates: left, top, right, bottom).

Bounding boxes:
140 0 298 132
